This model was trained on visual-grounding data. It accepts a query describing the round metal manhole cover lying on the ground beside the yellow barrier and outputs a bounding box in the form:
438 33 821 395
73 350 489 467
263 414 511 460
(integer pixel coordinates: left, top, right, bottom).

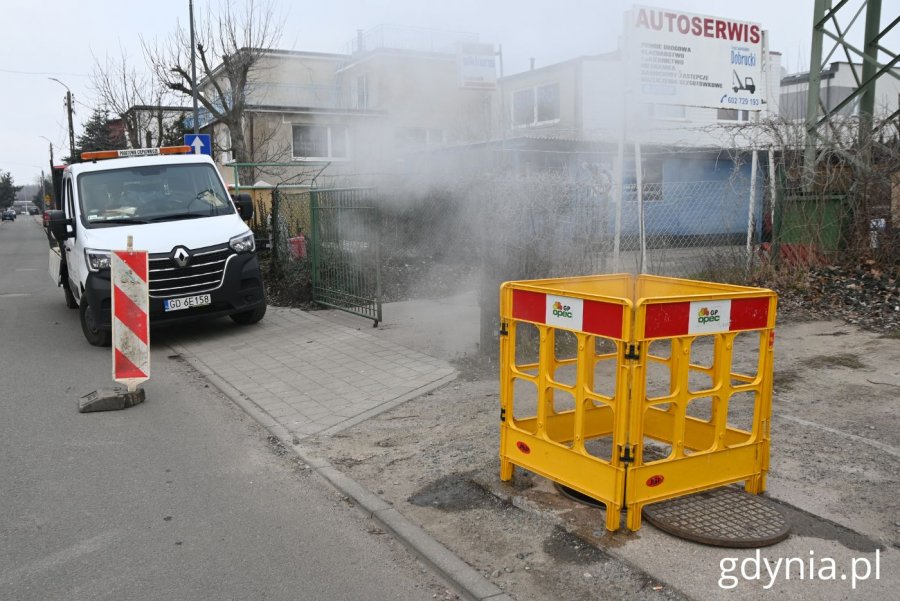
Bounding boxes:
642 487 790 549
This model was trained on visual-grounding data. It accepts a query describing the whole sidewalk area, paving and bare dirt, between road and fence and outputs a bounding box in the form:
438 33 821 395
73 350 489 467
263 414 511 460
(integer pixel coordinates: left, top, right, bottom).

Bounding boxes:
163 295 900 601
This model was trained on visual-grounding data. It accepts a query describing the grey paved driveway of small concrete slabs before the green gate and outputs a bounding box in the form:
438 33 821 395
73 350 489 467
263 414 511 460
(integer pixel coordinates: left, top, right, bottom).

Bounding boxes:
166 307 456 438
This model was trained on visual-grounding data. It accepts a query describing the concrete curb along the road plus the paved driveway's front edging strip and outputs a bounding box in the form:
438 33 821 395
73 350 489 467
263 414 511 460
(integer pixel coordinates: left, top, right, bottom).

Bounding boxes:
168 344 514 601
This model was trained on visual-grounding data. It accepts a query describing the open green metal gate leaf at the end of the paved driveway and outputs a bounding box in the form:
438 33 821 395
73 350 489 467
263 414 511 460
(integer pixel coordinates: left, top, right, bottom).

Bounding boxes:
310 188 381 326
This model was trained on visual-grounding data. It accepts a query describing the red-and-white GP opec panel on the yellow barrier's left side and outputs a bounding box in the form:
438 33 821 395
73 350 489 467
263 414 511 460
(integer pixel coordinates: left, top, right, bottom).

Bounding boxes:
512 289 625 340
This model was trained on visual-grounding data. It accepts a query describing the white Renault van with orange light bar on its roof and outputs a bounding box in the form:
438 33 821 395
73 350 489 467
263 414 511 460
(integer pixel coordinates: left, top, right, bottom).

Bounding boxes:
49 147 266 346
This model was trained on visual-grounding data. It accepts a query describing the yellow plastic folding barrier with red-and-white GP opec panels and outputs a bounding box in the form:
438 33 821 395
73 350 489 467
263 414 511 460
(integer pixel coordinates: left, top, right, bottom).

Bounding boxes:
500 275 776 530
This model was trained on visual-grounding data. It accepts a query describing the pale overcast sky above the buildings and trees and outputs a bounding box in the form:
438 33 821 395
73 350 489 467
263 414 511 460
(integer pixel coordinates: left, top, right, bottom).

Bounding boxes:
0 0 884 184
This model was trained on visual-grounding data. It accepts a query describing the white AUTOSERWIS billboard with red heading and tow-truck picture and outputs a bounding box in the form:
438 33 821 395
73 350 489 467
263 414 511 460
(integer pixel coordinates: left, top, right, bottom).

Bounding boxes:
625 6 767 111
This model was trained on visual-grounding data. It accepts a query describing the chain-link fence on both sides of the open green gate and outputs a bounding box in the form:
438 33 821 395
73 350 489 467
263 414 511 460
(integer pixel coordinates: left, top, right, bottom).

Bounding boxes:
257 166 771 312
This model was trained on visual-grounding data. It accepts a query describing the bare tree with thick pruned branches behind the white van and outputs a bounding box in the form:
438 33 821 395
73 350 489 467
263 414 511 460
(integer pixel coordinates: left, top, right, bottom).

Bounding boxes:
144 0 281 172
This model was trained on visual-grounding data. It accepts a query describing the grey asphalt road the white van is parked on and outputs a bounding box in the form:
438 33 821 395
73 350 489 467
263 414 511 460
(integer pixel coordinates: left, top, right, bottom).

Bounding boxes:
0 216 446 601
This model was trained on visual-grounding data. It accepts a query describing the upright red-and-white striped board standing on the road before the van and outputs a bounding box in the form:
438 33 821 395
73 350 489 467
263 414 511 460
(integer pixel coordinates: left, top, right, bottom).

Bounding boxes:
110 247 150 392
